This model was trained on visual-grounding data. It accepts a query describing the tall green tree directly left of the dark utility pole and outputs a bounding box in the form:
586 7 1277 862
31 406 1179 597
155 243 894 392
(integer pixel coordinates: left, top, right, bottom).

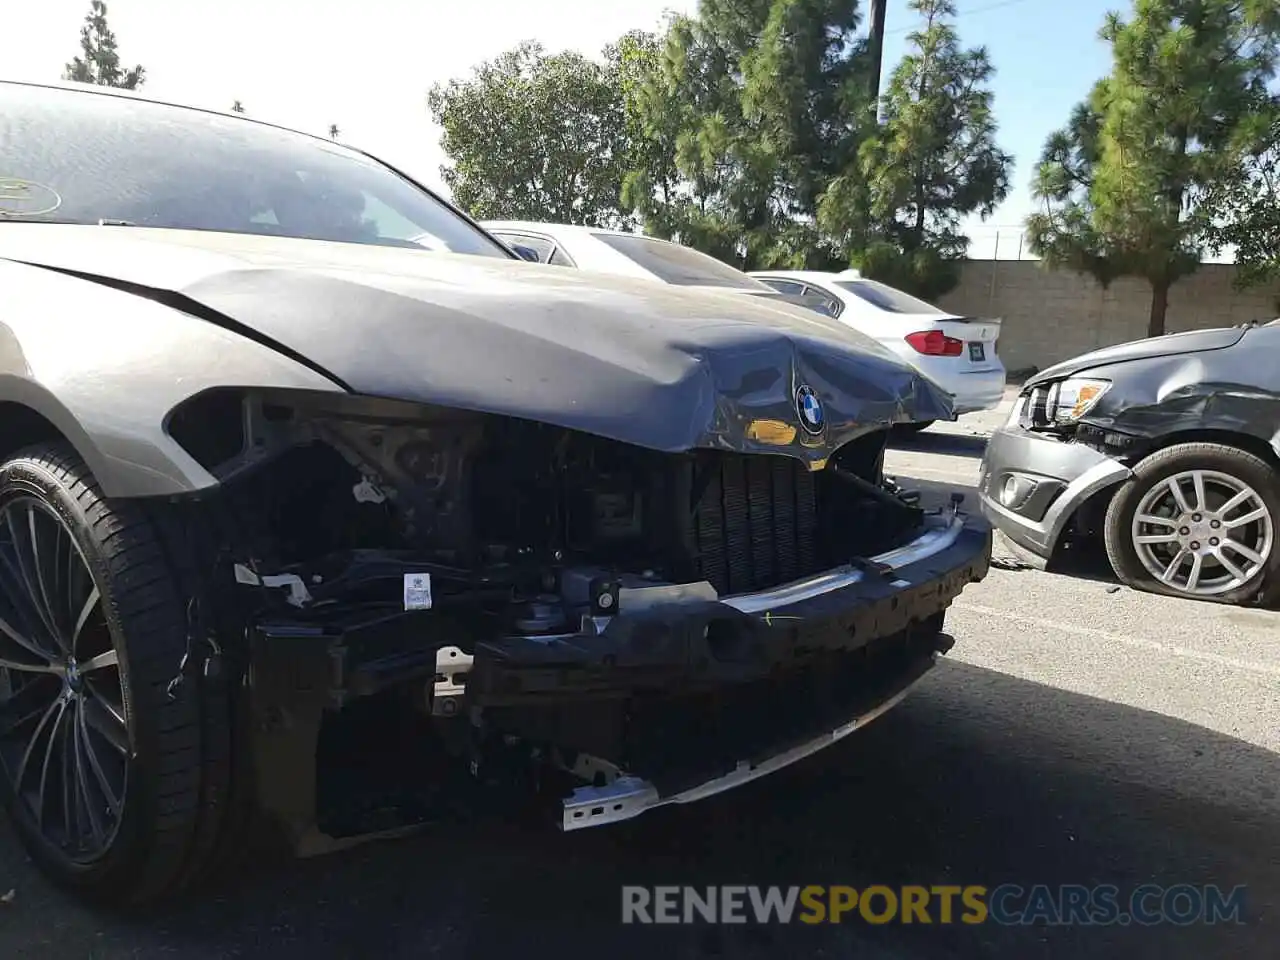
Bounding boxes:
625 0 867 269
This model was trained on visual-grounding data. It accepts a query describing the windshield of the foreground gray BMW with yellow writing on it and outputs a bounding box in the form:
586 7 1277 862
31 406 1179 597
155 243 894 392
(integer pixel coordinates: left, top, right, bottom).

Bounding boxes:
0 83 512 259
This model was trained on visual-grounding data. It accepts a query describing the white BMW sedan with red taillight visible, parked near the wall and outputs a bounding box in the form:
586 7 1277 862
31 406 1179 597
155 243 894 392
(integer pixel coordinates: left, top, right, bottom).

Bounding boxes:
751 270 1006 430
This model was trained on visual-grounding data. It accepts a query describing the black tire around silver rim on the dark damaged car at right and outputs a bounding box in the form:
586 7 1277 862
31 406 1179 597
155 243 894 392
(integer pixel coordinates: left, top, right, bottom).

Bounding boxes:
1103 443 1280 604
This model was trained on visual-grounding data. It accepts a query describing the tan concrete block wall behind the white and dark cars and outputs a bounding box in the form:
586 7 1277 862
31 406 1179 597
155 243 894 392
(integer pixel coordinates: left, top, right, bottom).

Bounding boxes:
938 260 1280 370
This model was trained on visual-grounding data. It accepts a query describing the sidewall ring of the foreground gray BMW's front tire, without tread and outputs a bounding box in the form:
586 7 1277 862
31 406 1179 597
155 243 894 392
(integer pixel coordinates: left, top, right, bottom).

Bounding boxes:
0 457 156 892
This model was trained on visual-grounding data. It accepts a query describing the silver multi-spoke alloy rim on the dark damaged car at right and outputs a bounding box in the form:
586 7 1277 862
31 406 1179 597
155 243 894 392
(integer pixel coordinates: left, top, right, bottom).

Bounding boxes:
1132 470 1275 596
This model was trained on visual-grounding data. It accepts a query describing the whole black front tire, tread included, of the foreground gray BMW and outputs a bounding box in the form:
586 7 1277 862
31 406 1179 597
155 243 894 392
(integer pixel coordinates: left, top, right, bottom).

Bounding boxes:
0 444 247 906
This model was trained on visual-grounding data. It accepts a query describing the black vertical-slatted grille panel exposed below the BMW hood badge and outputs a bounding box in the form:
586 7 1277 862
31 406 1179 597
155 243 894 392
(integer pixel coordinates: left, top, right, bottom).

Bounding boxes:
689 454 820 594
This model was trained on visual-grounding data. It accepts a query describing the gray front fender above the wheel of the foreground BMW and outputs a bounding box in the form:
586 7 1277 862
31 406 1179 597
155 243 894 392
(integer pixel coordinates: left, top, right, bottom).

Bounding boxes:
0 257 344 497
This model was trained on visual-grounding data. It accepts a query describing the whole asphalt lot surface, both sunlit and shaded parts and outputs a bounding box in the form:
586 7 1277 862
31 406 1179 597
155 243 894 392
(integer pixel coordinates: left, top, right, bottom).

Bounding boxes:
0 394 1280 960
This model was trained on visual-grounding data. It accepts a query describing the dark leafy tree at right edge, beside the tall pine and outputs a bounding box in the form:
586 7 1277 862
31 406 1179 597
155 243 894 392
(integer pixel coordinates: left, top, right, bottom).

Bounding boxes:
1204 111 1280 287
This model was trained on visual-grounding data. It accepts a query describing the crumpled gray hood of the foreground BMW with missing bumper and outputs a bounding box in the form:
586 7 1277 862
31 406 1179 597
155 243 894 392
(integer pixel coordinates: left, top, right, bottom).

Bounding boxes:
0 225 954 461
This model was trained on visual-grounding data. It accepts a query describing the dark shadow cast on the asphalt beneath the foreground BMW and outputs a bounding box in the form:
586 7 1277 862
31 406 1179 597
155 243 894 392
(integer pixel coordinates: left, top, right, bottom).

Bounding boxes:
0 670 1280 960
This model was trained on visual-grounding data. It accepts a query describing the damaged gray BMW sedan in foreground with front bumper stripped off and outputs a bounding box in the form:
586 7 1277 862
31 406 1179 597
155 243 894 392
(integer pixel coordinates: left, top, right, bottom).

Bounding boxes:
0 83 991 904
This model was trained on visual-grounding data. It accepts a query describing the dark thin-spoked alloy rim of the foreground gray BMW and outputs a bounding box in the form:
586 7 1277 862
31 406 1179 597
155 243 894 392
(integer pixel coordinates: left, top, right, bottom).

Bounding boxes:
0 495 131 863
